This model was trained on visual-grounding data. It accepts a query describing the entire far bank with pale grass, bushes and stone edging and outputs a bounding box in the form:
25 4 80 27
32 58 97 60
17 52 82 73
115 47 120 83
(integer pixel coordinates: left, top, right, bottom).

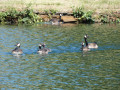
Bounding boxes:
0 0 120 23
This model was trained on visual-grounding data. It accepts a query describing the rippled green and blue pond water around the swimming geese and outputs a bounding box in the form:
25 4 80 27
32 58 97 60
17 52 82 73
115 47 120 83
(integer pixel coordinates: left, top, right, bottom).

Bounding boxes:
0 24 120 90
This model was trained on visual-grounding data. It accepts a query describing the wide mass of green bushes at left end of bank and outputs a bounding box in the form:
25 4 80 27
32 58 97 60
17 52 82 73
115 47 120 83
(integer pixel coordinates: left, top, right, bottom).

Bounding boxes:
0 7 42 24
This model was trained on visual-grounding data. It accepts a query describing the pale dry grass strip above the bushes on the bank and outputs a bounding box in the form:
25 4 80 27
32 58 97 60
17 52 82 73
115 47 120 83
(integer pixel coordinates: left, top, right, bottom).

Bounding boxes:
0 0 120 13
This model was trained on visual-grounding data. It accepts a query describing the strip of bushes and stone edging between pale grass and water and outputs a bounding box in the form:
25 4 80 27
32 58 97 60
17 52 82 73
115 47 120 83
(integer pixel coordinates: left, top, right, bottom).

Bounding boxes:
0 9 120 24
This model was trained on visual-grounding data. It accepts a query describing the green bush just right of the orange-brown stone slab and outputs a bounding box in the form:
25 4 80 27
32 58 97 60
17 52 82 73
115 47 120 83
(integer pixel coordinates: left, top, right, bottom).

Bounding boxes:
73 7 94 23
